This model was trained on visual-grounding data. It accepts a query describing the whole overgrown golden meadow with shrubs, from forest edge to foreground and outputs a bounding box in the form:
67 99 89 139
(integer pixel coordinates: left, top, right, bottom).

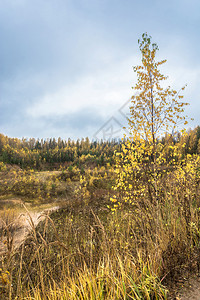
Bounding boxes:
0 128 200 300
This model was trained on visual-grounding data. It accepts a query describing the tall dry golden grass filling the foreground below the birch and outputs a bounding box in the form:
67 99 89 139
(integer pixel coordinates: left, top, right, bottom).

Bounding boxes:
1 165 200 300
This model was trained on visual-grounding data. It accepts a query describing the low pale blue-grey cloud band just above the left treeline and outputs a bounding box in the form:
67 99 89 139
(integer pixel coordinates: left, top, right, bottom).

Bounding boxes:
1 108 105 139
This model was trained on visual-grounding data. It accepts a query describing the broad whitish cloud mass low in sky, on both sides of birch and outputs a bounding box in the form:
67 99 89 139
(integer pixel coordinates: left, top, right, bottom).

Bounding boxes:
1 47 200 139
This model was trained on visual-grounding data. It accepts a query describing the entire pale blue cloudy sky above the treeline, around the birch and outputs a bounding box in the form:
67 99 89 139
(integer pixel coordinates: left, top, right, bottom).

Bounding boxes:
0 0 200 140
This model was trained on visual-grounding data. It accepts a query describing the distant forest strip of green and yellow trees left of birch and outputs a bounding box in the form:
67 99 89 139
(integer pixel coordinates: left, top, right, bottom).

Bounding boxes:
0 134 120 170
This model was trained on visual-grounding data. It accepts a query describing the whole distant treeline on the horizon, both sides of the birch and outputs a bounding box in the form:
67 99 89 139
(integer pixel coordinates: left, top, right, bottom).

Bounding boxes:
0 126 200 169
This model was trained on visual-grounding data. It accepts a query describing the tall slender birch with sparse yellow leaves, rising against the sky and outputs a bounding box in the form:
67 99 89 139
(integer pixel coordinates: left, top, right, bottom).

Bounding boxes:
111 34 191 209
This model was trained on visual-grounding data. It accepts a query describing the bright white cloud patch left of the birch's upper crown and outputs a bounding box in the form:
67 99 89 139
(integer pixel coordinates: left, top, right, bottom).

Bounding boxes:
27 56 136 118
